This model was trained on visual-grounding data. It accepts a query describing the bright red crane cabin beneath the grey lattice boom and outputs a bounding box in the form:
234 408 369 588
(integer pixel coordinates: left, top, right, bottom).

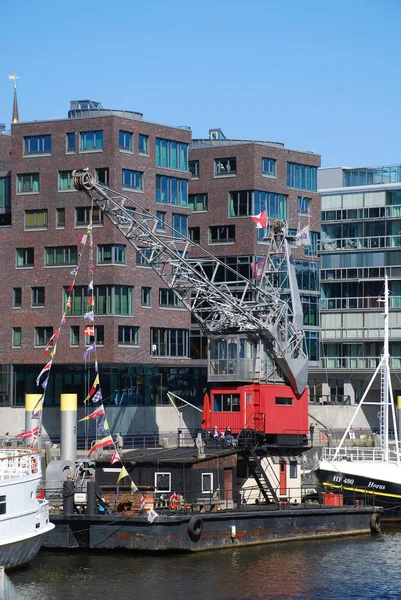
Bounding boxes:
202 383 308 442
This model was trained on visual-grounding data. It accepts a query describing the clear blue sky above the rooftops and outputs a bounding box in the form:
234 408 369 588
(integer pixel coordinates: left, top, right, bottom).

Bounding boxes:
0 0 401 166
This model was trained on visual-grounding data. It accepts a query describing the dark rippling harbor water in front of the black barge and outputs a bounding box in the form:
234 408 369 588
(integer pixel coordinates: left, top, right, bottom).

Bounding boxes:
10 532 401 600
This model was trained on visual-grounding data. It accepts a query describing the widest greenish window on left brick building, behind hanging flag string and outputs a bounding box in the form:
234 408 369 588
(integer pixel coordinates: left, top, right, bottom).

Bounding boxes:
64 285 134 316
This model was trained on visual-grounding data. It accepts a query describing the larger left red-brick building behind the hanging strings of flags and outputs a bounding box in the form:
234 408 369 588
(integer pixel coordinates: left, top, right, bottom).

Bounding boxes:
0 101 205 430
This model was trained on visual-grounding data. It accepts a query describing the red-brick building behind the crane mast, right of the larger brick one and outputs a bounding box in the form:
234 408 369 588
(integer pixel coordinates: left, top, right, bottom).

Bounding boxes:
189 129 320 365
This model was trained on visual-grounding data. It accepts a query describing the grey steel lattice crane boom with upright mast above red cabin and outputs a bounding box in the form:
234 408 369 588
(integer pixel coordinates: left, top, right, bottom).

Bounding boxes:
73 170 308 395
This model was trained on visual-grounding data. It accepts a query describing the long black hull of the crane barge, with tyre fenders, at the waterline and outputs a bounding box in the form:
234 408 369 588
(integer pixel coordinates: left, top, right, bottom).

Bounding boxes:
43 507 380 552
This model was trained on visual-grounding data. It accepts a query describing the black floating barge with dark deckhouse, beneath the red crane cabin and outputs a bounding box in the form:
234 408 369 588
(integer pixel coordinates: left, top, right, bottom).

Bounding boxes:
44 448 380 552
